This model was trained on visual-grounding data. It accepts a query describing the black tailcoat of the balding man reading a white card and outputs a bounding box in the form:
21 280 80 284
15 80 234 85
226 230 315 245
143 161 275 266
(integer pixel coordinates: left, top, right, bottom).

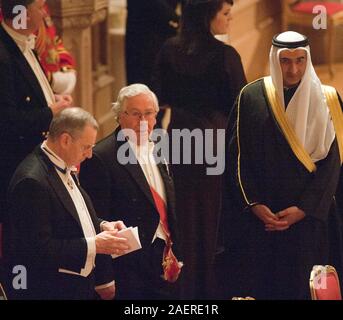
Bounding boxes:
5 147 113 299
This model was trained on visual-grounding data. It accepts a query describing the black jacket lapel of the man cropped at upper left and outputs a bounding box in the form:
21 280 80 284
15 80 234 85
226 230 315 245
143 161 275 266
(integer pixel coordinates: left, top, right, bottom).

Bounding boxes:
0 25 47 106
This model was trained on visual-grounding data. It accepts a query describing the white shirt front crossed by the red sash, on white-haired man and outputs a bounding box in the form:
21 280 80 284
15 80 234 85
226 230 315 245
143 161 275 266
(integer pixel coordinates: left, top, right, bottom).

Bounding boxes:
129 141 167 243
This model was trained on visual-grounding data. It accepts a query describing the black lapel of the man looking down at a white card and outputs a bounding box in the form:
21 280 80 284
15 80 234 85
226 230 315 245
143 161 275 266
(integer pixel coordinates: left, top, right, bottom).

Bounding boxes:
36 146 82 228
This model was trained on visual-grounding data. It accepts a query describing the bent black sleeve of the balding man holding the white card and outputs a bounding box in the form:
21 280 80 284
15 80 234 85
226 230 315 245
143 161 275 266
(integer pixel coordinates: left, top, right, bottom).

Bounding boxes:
9 178 87 272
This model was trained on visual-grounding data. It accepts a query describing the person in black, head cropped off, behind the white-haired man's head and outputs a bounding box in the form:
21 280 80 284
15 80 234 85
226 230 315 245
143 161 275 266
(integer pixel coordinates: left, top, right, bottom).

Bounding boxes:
125 0 180 85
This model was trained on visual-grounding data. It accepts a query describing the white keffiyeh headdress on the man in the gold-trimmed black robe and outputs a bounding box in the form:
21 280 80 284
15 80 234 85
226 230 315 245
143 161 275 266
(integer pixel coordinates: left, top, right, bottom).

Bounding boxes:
269 31 335 162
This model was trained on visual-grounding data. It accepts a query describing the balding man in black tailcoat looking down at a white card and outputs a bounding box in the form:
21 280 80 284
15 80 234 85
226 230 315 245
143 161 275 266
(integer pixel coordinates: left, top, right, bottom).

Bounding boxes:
4 108 130 300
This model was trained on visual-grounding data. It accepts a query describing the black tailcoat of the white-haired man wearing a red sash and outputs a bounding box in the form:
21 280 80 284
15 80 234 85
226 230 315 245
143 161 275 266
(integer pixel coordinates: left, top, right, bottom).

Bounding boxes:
80 128 180 299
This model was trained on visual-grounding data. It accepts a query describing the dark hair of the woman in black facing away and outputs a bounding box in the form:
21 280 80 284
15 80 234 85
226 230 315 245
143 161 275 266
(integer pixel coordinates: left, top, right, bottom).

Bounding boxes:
180 0 233 51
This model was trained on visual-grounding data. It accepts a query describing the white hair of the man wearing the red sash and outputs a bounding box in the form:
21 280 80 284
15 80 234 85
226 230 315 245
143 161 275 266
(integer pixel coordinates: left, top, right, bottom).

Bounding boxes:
112 83 160 120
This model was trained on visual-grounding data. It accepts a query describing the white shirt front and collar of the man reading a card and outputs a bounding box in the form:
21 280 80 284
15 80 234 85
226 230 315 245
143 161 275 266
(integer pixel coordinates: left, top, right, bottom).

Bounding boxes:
41 141 96 277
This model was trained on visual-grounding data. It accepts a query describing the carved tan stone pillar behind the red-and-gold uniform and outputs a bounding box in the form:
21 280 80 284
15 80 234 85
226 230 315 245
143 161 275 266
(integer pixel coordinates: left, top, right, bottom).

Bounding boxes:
47 0 114 138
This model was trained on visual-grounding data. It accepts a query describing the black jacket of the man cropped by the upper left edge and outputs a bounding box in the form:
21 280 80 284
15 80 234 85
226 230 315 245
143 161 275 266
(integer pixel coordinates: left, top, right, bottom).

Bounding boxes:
0 25 52 221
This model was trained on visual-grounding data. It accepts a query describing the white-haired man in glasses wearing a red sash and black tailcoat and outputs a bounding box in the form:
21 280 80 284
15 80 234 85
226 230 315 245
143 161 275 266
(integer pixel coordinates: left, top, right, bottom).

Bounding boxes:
80 84 182 299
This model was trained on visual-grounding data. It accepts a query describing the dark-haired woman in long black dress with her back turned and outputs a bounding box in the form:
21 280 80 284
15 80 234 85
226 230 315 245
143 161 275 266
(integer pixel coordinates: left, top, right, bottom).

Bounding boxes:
153 0 246 299
